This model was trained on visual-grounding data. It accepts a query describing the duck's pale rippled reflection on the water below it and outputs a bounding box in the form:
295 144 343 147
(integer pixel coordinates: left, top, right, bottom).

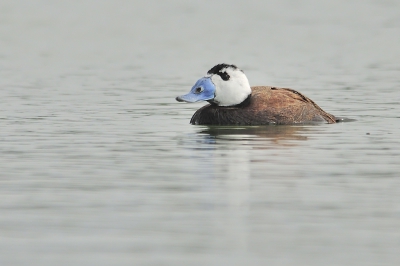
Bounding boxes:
177 125 317 252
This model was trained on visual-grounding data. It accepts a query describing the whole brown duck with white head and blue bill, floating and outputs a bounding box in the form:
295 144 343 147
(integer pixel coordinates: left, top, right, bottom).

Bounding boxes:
176 63 339 126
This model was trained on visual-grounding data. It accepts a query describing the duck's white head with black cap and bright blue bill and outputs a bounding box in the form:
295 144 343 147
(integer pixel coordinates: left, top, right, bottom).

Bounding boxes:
176 64 251 106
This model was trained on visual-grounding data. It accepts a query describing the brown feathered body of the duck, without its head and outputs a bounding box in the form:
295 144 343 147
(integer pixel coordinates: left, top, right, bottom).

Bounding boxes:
190 86 336 126
